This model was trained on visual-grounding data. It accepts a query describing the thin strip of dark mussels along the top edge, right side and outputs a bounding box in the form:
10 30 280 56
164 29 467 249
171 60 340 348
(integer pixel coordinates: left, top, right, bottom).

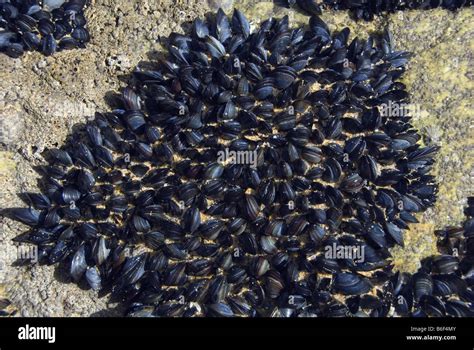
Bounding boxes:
275 0 473 21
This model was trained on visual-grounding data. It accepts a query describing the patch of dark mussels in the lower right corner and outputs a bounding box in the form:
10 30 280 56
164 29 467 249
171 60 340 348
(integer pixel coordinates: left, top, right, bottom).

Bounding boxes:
385 197 474 317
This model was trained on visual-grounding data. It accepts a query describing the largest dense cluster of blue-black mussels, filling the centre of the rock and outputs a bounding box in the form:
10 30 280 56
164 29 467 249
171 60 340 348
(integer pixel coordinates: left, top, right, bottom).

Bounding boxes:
4 10 451 316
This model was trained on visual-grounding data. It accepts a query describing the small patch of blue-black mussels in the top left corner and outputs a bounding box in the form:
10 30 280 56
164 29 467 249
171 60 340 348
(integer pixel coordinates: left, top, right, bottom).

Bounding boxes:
0 0 90 58
